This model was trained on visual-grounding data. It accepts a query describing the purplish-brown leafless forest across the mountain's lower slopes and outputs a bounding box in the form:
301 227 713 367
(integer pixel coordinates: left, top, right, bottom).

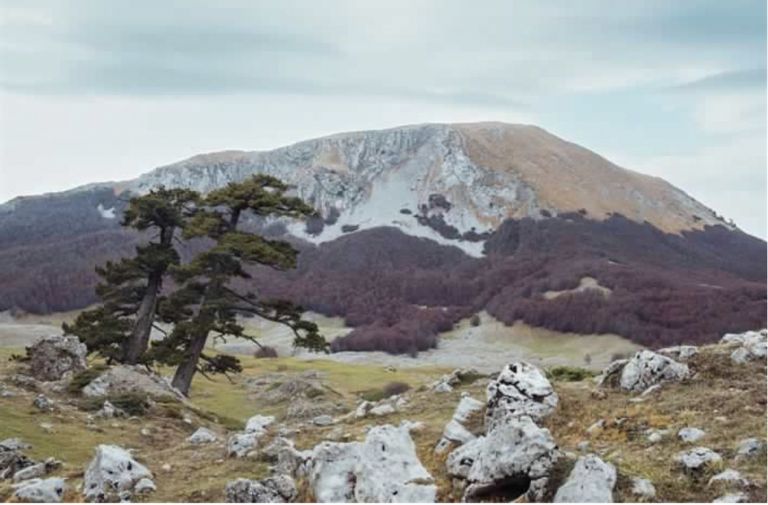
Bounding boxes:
0 190 766 354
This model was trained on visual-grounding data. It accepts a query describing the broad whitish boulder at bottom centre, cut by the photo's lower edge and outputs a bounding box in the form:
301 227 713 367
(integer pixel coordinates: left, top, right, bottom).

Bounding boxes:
307 423 437 503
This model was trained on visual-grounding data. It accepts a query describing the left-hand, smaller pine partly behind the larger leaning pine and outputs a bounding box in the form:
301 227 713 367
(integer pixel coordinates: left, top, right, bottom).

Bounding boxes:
63 186 200 364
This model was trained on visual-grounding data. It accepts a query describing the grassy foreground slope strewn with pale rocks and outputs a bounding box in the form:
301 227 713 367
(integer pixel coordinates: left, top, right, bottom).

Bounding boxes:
0 330 768 503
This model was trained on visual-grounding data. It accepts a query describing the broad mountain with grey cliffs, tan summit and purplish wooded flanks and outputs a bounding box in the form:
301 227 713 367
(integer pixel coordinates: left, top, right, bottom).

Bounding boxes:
0 123 766 352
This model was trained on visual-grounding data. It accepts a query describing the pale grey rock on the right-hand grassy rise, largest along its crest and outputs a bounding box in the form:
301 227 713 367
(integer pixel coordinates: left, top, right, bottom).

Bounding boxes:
598 350 690 393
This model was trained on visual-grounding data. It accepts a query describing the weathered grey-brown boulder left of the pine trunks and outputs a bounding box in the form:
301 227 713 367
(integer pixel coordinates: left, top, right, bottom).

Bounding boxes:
26 335 88 381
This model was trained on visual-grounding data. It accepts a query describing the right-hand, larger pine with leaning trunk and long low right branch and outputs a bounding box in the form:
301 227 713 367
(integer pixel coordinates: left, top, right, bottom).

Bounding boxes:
148 175 328 395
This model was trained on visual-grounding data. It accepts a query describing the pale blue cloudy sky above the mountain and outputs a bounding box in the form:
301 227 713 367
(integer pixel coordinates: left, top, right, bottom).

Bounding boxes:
0 0 766 237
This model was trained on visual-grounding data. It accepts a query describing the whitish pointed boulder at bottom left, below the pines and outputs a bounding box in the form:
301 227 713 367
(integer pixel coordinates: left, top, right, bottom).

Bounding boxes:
83 445 154 502
